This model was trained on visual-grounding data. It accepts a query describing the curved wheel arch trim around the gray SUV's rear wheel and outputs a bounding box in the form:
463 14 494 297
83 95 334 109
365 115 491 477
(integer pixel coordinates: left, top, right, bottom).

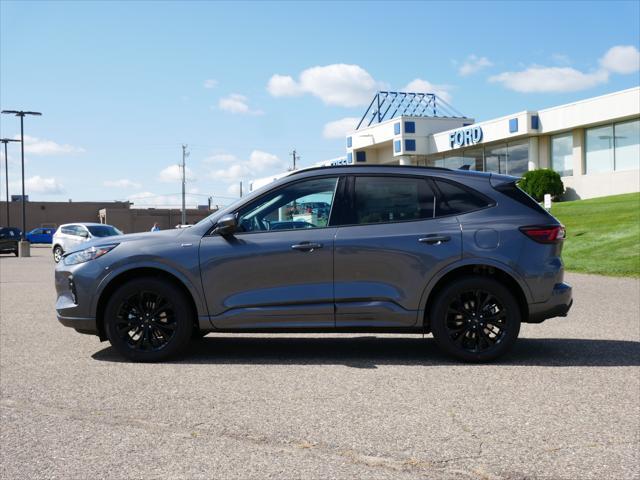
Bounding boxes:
422 262 530 330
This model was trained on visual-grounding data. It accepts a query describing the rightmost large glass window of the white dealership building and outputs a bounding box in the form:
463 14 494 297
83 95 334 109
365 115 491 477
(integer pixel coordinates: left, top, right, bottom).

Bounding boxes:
585 119 640 174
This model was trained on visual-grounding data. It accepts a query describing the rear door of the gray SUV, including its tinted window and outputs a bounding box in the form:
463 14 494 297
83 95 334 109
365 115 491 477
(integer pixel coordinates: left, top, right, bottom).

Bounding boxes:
334 175 462 327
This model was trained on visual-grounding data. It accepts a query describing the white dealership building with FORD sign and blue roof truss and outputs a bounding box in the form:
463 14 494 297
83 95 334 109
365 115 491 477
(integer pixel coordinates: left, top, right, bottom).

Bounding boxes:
340 87 640 199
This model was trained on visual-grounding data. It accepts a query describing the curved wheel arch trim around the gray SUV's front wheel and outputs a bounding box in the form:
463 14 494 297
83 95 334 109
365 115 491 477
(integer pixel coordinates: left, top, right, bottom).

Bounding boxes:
95 266 199 340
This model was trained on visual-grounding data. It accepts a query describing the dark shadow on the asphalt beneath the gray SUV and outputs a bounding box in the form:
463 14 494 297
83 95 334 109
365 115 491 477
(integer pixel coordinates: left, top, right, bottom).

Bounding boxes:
92 335 640 368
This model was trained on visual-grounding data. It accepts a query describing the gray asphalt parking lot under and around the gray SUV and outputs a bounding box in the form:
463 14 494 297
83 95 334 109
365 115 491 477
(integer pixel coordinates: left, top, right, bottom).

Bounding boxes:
0 249 640 480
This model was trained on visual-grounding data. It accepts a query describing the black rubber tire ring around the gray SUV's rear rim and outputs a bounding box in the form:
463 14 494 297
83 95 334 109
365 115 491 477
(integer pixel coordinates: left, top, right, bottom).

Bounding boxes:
430 276 522 362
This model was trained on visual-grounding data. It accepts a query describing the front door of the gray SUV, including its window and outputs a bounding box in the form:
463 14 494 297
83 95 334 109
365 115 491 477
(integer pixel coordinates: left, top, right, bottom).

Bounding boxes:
200 176 338 329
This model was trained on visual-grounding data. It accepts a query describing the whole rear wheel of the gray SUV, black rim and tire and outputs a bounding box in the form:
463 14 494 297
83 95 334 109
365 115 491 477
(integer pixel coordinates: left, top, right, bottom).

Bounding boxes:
430 276 521 362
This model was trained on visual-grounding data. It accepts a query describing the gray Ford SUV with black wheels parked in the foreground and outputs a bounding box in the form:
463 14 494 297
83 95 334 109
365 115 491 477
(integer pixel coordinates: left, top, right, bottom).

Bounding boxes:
55 166 572 362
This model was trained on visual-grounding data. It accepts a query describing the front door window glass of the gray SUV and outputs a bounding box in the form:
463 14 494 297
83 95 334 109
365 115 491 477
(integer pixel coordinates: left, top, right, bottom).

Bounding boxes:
238 177 338 232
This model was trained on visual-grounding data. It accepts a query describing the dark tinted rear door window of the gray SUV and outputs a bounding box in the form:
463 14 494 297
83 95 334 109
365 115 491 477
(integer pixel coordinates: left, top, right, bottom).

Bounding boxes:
353 176 435 225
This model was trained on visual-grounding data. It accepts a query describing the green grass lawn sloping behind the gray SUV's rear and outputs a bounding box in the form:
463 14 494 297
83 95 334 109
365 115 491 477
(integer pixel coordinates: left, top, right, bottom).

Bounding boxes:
551 193 640 277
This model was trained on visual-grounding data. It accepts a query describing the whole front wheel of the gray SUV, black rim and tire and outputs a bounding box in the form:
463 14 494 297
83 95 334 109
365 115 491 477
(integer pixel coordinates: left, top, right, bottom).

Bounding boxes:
104 277 194 362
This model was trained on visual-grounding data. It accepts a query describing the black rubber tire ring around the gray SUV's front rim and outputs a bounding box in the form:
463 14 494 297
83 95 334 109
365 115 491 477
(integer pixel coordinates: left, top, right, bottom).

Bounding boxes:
104 277 193 362
